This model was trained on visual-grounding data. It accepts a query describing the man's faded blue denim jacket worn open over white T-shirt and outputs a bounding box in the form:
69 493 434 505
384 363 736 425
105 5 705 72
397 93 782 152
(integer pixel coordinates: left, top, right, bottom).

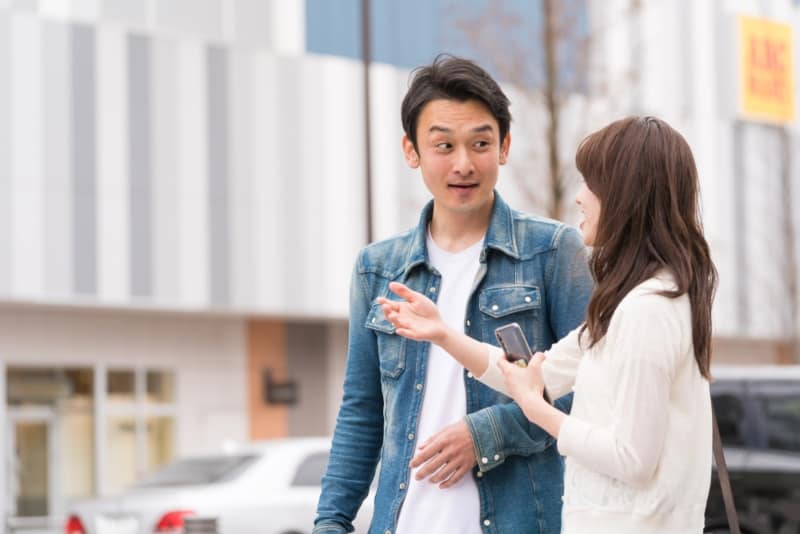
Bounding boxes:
313 192 592 534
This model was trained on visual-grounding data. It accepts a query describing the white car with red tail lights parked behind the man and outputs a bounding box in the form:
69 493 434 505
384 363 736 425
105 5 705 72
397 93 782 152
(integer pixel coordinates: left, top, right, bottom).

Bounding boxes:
64 438 373 534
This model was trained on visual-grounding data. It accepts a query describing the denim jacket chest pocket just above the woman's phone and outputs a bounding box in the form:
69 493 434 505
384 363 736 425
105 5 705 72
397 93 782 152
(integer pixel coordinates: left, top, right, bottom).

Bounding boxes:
478 285 542 350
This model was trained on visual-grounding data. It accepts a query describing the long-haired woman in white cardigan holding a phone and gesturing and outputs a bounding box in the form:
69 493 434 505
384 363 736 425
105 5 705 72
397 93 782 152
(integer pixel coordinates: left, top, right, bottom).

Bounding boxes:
379 117 717 534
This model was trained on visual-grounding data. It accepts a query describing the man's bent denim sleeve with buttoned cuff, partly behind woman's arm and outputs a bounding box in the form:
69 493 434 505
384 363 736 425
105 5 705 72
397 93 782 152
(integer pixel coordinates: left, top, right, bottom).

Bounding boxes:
467 226 593 471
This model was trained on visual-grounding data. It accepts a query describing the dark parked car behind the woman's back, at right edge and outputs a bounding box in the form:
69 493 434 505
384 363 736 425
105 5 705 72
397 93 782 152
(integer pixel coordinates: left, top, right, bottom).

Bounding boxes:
706 366 800 534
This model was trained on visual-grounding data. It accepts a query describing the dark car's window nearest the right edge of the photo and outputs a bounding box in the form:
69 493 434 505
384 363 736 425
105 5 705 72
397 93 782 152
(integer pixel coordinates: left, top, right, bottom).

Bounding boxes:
750 381 800 452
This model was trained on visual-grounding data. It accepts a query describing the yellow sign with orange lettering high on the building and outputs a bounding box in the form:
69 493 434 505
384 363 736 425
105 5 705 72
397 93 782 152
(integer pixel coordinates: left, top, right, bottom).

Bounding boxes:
739 16 794 123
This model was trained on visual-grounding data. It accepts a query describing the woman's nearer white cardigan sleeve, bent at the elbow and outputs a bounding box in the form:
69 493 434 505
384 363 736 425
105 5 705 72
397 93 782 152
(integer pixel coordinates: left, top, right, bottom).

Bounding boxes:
558 294 682 487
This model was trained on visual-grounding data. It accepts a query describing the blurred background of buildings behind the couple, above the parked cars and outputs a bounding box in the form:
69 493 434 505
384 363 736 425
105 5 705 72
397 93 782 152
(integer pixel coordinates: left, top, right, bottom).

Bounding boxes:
0 0 800 532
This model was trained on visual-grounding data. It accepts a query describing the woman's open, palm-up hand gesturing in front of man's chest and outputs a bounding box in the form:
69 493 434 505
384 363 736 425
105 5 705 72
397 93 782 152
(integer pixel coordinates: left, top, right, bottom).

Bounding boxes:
377 282 447 344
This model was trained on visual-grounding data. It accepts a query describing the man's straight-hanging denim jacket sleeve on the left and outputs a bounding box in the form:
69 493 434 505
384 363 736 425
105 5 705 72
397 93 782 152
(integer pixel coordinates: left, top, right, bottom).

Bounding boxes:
313 253 383 534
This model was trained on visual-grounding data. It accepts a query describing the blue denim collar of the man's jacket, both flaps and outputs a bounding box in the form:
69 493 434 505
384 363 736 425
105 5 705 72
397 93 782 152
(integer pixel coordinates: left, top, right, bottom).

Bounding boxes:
404 190 519 277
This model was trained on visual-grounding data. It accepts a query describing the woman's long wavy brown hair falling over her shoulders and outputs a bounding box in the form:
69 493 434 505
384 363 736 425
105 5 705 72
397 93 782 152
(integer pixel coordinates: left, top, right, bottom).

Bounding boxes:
575 117 717 378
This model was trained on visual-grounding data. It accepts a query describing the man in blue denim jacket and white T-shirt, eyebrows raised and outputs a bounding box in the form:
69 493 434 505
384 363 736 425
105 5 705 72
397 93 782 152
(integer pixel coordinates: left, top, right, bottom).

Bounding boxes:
314 56 592 534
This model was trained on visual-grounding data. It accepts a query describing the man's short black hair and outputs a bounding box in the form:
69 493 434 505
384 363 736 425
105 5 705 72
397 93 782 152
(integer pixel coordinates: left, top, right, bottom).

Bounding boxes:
400 54 511 152
